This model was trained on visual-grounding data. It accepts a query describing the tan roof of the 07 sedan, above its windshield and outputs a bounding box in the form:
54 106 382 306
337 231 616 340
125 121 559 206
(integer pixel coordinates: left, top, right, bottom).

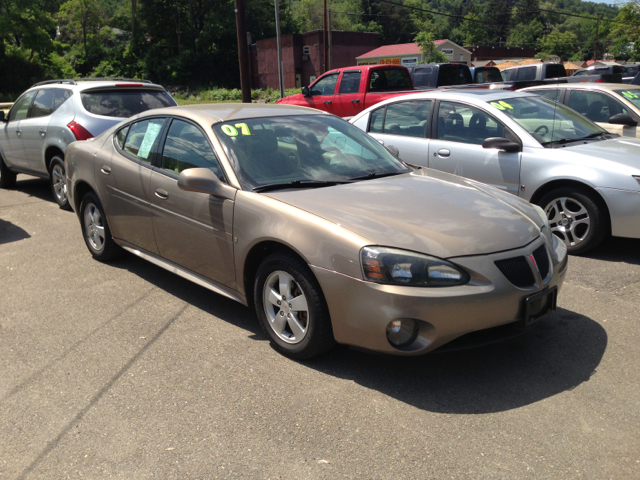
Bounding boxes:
140 103 330 123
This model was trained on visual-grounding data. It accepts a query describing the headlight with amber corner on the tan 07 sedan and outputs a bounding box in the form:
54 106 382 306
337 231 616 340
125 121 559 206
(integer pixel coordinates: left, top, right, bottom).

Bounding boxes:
360 247 470 287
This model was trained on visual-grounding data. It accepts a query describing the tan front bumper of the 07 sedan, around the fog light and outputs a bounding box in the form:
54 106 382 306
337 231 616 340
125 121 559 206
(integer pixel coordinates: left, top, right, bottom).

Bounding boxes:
312 237 567 355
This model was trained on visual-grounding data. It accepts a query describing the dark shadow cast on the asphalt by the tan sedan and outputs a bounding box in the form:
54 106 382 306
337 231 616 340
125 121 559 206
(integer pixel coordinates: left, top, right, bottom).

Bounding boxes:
104 254 607 414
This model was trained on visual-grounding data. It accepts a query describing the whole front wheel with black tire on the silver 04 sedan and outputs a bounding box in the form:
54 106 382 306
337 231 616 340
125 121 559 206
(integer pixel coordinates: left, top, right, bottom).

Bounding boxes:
539 187 611 255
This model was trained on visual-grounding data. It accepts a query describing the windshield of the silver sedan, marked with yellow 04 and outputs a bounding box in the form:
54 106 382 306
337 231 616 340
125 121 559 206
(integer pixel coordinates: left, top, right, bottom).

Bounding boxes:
489 96 607 147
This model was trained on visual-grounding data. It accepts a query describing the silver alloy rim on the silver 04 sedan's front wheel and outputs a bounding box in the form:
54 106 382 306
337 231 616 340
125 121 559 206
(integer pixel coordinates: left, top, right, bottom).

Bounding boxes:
544 197 591 247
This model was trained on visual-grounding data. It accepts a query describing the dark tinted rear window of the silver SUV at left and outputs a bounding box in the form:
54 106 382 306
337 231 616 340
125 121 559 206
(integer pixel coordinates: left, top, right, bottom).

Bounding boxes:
80 89 177 118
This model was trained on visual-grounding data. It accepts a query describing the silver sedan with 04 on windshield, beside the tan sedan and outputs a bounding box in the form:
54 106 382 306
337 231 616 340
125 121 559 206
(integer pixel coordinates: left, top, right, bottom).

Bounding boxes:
350 90 640 254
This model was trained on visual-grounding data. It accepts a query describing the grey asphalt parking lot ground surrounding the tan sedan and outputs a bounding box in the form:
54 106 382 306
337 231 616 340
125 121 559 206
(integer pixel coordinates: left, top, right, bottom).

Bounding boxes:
0 175 640 480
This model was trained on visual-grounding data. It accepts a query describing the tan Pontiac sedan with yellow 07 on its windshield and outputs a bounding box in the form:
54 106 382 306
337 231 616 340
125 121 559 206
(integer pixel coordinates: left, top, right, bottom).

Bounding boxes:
66 104 567 358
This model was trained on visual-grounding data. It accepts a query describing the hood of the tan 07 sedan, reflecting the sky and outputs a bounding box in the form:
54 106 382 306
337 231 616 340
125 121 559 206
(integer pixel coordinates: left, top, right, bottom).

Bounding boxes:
264 169 542 258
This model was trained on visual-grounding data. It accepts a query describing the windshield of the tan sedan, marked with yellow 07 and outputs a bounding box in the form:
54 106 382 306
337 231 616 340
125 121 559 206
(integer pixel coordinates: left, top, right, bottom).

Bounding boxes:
213 115 410 190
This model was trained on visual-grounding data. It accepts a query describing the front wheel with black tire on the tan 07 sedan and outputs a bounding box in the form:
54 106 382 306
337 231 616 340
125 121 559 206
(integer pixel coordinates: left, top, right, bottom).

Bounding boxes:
253 252 335 359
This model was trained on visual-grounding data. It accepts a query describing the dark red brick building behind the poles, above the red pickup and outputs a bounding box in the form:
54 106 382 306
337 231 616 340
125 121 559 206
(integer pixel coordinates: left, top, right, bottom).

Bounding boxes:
251 30 380 90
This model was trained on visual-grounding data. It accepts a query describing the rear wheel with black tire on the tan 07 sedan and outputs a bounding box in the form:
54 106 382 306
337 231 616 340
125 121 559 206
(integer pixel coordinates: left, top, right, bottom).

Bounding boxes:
80 193 123 262
